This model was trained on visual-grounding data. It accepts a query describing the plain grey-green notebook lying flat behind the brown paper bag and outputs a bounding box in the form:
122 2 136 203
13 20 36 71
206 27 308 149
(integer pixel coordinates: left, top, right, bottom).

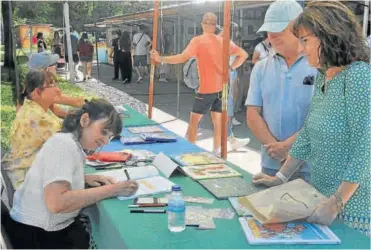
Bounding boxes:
199 177 265 199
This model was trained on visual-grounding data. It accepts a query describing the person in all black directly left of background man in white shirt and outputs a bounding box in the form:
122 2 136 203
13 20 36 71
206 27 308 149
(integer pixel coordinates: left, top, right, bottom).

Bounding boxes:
117 31 132 84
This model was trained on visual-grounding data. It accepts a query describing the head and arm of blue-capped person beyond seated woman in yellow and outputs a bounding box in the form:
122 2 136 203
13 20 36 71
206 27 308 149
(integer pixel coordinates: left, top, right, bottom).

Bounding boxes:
28 52 85 118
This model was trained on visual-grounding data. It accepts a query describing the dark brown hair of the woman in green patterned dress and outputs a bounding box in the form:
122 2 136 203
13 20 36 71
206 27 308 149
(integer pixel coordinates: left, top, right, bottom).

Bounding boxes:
293 1 370 70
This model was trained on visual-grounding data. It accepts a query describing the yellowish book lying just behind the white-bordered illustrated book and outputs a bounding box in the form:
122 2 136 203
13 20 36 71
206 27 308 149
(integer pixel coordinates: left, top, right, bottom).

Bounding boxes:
171 152 224 166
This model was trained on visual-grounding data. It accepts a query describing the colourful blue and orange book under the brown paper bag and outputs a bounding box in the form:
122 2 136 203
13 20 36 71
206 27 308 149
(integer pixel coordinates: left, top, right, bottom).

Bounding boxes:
238 217 341 245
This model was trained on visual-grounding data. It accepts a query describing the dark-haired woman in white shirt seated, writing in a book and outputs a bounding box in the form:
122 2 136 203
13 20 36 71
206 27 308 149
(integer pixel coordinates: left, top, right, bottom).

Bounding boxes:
7 99 138 249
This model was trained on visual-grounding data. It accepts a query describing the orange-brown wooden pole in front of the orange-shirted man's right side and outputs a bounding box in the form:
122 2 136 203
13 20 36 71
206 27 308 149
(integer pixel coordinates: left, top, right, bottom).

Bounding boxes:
221 0 232 159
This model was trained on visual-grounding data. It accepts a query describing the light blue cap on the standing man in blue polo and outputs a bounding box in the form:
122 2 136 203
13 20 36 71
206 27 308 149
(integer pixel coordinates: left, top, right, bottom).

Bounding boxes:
258 0 303 32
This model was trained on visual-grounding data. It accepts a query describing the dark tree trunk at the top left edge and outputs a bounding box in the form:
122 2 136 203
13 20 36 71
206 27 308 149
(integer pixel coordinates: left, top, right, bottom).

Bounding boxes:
1 1 14 69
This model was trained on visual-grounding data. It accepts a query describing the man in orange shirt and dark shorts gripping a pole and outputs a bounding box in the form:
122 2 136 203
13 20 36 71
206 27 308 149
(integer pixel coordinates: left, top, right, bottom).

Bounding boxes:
151 12 248 153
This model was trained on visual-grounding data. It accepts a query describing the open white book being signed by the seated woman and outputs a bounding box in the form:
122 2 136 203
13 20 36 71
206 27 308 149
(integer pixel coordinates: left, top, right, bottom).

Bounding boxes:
87 166 175 200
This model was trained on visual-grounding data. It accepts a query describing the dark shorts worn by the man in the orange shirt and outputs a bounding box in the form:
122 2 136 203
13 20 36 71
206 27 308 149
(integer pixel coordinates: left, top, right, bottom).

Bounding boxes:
192 92 222 115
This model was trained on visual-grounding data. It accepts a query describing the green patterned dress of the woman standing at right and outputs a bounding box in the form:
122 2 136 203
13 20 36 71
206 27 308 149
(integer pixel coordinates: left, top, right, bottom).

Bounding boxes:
290 62 371 236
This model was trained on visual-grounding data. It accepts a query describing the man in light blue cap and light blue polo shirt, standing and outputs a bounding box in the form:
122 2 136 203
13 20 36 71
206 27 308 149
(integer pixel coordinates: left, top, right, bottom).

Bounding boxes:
245 0 317 181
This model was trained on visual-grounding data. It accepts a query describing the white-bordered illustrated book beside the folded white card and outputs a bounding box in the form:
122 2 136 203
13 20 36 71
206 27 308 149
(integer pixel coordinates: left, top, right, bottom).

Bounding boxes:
182 164 241 180
